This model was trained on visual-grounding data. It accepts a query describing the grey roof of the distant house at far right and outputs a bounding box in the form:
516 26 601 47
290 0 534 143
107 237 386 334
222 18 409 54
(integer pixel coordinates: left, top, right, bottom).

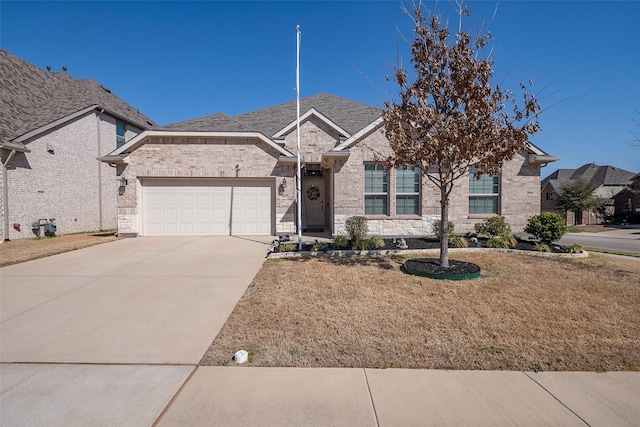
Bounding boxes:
540 163 636 190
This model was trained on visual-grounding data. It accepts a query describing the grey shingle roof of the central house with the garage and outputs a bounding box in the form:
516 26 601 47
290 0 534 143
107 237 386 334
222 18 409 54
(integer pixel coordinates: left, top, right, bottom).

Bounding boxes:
162 93 382 137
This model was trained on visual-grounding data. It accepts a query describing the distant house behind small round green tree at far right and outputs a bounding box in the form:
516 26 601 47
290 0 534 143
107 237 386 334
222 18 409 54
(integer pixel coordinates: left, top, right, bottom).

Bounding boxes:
540 163 634 225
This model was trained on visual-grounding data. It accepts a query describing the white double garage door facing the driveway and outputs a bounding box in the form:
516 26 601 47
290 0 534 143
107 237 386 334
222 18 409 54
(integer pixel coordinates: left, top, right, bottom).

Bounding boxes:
142 180 273 236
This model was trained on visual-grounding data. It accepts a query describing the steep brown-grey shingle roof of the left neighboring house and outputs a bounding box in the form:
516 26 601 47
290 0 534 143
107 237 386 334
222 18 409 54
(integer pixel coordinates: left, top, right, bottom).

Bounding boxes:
0 49 156 143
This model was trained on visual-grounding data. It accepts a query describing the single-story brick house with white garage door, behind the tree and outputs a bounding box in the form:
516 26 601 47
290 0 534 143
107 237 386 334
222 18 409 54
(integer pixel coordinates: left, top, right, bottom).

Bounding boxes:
101 94 558 236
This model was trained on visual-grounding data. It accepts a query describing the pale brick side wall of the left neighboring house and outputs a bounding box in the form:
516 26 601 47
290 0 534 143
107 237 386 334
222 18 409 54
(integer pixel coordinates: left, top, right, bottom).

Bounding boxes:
0 112 138 240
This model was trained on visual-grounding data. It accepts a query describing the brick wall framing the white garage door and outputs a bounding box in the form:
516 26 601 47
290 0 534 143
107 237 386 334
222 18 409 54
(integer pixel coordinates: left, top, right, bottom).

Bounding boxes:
118 137 295 234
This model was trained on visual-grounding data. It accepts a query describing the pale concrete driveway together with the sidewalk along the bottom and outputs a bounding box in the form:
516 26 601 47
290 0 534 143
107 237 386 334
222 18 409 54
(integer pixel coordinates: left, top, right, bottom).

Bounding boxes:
0 237 640 427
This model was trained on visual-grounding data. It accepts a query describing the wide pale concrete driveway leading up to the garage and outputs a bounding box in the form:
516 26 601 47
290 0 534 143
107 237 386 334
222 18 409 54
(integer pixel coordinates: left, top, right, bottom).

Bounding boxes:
0 236 271 426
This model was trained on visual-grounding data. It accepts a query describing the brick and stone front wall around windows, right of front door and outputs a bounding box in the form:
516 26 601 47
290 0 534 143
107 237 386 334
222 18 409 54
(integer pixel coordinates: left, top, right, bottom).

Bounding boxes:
333 130 540 236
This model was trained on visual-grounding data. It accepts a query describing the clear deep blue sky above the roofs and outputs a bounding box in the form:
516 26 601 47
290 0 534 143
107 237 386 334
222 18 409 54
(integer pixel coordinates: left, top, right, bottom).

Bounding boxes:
0 0 640 177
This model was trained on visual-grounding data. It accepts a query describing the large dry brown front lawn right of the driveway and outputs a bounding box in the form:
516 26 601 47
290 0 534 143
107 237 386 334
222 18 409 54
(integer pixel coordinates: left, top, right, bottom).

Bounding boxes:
201 253 640 371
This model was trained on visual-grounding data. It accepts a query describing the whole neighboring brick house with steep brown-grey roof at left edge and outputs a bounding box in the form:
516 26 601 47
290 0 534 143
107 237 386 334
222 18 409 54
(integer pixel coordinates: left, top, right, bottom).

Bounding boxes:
0 49 154 240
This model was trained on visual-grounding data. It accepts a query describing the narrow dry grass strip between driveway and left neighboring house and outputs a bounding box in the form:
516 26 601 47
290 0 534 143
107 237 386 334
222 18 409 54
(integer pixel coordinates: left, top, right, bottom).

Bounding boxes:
0 233 118 267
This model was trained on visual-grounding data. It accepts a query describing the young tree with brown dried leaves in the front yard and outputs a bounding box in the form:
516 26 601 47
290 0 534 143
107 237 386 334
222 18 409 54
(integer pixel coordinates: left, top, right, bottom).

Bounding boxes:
383 5 540 268
